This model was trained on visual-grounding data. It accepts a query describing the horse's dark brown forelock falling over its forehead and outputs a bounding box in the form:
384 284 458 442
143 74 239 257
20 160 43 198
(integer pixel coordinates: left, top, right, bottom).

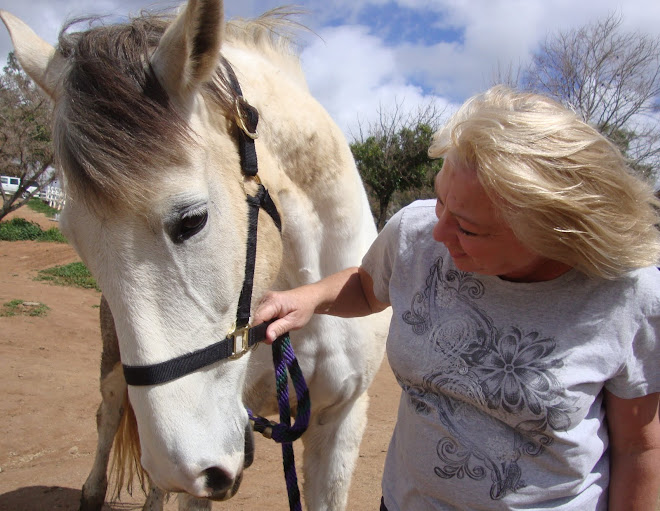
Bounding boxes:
54 16 190 210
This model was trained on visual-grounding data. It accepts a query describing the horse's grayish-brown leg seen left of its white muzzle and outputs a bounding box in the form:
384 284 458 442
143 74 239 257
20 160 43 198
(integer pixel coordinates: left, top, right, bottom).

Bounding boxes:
80 296 126 511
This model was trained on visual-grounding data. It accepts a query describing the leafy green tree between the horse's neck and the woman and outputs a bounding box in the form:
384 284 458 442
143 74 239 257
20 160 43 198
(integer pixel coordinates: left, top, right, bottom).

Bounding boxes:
350 104 442 230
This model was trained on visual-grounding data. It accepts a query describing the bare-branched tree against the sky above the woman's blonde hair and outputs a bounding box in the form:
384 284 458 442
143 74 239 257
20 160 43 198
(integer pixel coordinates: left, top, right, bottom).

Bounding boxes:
521 14 660 182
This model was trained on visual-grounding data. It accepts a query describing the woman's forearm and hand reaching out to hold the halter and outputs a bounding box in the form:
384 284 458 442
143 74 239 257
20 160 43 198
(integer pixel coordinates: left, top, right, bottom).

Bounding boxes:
253 267 389 343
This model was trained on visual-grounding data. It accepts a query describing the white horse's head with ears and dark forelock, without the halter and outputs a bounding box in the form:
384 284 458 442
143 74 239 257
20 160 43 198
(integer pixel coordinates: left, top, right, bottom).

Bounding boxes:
2 0 283 499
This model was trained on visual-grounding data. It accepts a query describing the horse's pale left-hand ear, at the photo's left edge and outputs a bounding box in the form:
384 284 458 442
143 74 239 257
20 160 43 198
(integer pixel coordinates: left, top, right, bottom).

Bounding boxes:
0 10 64 99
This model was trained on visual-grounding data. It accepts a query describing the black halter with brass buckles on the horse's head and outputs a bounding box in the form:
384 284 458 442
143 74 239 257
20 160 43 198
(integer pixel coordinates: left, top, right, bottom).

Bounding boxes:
123 58 282 386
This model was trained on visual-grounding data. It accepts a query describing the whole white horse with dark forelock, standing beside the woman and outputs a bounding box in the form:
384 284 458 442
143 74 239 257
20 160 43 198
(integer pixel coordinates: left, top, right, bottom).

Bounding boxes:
1 0 387 510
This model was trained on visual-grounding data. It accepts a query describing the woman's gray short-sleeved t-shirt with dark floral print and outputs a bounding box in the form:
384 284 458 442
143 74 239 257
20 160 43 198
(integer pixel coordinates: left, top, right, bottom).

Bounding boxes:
362 200 660 511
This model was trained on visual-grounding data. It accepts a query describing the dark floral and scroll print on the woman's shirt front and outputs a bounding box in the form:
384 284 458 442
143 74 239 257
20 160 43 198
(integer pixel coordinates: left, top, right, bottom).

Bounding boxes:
397 258 572 500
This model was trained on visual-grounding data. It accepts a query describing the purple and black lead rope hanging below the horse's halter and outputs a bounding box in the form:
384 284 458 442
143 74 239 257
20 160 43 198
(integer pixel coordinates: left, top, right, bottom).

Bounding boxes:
248 333 311 511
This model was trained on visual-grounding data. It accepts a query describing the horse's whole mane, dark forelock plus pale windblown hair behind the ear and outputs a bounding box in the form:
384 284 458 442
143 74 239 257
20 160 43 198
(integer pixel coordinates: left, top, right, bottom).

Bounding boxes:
53 8 304 209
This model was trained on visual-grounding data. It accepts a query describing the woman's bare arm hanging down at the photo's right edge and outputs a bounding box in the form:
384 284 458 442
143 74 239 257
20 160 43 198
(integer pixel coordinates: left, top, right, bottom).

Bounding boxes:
605 391 660 511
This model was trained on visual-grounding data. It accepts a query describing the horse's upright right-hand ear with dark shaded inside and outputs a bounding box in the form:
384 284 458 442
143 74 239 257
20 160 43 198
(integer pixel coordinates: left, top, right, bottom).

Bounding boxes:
151 0 224 98
